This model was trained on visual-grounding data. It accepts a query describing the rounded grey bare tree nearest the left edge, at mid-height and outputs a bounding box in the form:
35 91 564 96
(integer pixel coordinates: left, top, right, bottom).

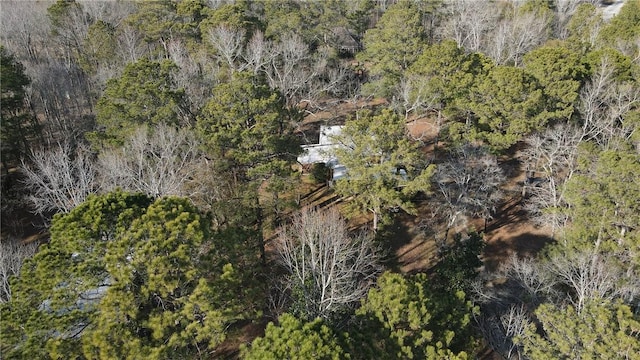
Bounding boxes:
22 143 96 215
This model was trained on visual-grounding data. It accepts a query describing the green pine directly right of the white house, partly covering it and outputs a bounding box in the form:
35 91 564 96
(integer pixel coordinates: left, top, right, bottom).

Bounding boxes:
335 110 434 230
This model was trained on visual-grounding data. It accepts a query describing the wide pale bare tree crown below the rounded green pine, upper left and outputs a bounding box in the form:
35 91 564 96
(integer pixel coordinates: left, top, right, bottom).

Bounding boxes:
99 125 204 197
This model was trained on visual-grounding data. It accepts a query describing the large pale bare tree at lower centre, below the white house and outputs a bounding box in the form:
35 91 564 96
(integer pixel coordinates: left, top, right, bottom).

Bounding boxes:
277 209 380 320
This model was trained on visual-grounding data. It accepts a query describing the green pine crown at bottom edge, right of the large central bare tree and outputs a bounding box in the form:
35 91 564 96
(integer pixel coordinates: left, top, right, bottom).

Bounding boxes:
357 272 477 359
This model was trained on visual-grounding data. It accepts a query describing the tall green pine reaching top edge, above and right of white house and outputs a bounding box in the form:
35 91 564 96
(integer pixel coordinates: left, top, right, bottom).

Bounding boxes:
358 1 426 96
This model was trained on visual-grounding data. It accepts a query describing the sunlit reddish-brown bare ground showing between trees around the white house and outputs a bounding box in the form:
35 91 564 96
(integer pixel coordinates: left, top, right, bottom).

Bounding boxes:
302 100 550 273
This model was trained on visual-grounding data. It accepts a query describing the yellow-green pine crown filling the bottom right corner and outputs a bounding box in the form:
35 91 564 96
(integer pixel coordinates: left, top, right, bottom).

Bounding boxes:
517 300 640 360
